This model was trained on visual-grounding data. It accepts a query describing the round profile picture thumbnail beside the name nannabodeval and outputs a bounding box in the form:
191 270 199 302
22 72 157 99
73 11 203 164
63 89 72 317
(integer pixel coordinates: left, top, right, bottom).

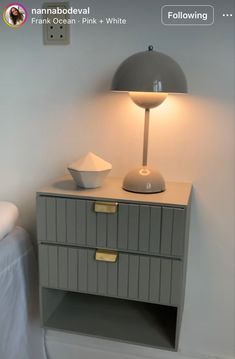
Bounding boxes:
3 3 28 28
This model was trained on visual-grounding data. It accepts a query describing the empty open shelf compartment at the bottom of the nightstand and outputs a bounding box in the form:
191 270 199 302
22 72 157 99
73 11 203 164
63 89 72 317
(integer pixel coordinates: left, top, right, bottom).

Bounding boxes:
41 288 177 350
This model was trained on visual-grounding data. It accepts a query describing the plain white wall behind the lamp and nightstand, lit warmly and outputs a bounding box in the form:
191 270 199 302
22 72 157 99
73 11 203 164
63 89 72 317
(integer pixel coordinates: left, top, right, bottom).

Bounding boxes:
0 0 235 357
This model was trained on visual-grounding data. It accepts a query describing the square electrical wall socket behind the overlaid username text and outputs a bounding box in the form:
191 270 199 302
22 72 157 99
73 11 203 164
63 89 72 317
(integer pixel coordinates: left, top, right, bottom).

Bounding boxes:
43 2 70 45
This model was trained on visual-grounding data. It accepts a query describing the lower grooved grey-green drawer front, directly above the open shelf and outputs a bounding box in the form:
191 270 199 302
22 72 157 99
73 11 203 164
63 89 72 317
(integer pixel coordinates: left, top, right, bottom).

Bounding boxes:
39 244 182 306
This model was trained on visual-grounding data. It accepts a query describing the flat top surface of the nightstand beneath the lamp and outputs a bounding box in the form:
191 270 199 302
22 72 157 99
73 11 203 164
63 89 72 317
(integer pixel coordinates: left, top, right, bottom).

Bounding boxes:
38 175 192 207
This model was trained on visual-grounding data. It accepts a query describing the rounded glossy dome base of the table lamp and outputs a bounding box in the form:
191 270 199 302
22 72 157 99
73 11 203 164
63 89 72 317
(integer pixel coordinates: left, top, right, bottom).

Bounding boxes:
122 166 166 193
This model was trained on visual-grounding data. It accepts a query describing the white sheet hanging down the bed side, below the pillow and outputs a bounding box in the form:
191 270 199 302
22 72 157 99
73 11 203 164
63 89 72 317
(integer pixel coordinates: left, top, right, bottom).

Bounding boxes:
0 227 45 359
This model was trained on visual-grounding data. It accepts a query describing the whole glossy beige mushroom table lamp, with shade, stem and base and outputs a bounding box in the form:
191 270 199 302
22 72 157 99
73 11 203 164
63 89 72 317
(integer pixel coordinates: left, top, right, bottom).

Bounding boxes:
112 46 187 193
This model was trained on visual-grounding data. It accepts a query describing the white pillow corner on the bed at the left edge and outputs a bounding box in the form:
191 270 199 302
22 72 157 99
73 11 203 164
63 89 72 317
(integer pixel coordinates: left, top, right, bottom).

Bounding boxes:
0 201 19 240
